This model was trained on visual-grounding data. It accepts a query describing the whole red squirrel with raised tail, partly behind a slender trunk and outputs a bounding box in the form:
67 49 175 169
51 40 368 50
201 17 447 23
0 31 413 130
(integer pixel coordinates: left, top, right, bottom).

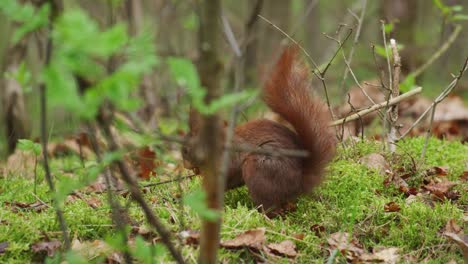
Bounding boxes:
182 46 336 214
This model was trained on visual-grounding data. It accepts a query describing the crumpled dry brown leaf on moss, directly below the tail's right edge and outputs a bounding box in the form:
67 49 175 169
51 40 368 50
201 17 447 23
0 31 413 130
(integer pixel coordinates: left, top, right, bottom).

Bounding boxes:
327 232 364 260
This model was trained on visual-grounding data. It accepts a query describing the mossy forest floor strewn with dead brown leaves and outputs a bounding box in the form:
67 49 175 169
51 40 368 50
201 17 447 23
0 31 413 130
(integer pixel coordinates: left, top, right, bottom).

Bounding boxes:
0 138 468 263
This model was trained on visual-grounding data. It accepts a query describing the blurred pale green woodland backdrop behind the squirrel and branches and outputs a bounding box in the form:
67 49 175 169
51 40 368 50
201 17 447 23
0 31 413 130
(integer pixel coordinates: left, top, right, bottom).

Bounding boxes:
0 0 468 157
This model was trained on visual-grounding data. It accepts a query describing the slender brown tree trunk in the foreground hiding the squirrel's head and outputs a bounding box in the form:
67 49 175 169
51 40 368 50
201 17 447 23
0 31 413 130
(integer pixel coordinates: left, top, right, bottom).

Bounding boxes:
195 0 224 263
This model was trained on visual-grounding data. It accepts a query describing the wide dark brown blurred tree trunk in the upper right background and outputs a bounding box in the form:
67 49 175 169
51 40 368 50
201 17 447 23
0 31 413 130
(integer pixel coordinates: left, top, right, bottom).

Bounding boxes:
379 0 418 75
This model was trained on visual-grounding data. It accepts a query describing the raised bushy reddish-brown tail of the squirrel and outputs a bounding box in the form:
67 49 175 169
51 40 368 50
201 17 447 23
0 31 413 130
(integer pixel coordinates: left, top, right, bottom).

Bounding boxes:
263 46 336 192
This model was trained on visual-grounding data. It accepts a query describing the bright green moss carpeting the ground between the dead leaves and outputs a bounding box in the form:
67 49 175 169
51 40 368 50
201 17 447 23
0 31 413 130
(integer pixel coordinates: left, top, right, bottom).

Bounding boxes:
0 138 468 263
